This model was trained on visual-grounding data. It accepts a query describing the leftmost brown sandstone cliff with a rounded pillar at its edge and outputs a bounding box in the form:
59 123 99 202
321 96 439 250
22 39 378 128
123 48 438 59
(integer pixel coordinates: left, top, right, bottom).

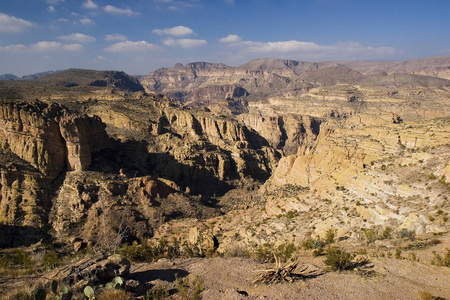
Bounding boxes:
0 101 107 227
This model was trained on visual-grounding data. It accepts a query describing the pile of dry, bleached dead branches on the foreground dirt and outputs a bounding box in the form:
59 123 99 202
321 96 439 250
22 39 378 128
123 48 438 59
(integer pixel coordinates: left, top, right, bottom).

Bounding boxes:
252 255 323 284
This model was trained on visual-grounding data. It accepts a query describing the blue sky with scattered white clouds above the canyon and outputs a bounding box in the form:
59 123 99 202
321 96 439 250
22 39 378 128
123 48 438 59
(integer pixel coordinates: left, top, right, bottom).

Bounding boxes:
0 0 450 76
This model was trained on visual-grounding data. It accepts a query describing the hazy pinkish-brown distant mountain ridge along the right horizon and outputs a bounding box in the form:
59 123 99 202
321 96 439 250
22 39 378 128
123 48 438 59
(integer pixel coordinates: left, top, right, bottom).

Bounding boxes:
140 56 450 107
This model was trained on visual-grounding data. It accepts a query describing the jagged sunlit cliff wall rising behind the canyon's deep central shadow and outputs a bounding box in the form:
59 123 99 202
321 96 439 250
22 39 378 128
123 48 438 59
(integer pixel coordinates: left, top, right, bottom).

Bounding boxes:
89 97 279 193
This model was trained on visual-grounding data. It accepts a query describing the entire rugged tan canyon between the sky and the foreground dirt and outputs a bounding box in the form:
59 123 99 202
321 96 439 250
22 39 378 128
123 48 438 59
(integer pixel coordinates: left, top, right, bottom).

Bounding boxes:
0 57 450 296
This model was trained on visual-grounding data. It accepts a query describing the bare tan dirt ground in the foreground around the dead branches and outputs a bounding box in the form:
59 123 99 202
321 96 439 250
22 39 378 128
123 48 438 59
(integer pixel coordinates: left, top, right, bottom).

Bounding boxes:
131 254 450 300
